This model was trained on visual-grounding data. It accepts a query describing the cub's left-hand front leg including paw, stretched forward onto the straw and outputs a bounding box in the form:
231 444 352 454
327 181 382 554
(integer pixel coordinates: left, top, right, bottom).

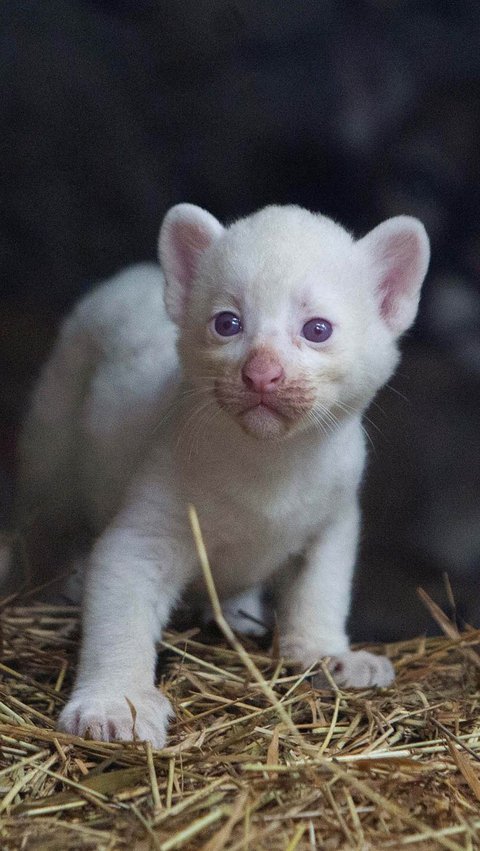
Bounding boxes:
59 522 192 748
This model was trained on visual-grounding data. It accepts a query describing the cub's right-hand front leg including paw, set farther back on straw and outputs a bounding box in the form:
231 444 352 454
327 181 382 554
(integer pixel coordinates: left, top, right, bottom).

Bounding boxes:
277 504 395 688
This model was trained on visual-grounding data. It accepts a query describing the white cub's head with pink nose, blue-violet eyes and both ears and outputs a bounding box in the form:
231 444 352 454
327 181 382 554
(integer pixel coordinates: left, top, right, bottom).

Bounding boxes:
160 204 429 438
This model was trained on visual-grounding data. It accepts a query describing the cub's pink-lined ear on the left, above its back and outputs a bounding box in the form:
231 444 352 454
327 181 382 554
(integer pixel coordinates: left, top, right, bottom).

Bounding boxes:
158 204 223 324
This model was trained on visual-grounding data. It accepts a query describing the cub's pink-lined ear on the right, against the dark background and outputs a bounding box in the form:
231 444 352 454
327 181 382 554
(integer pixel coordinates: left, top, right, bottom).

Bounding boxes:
358 216 430 336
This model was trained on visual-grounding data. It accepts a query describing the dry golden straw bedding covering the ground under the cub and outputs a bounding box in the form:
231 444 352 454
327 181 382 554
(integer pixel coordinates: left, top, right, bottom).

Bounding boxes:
0 598 480 851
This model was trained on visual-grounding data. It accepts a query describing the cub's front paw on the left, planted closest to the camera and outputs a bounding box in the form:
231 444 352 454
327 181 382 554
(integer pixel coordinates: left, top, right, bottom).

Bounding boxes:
58 686 173 748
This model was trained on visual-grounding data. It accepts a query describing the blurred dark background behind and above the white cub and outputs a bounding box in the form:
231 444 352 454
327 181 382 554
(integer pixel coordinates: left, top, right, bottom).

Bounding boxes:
0 0 480 640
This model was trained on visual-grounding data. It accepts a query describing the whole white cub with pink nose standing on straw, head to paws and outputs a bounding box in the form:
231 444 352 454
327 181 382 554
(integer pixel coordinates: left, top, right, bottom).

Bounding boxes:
17 204 429 747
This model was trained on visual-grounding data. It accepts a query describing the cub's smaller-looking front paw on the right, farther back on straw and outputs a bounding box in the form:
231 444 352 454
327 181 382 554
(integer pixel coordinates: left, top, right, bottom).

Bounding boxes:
328 650 395 688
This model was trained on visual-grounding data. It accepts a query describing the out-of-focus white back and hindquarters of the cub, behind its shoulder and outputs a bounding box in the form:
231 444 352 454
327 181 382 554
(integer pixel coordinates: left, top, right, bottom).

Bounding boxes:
19 264 177 529
